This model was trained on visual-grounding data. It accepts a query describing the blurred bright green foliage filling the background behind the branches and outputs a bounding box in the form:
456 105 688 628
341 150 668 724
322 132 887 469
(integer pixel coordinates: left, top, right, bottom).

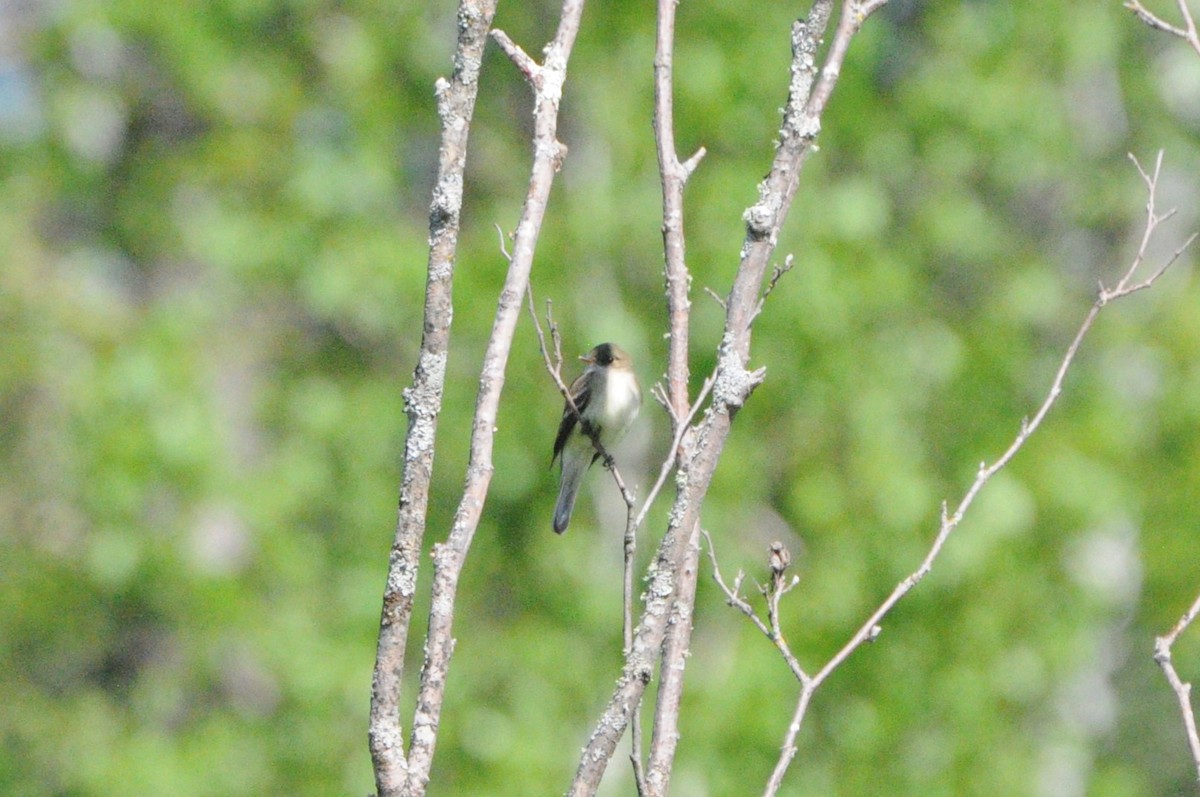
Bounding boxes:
7 0 1200 797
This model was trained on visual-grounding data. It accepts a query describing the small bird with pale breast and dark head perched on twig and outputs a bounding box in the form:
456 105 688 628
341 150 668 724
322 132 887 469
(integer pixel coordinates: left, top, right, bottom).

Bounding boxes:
550 343 642 534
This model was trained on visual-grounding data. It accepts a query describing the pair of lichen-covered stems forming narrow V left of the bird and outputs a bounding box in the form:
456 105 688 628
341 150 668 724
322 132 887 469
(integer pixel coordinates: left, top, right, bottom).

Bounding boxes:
370 0 583 797
